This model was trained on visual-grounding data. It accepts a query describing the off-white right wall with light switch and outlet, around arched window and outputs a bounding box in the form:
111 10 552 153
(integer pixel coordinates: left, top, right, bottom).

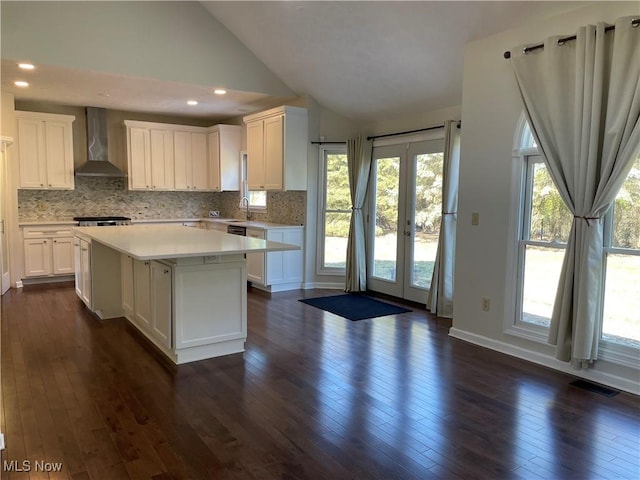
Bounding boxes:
452 2 640 391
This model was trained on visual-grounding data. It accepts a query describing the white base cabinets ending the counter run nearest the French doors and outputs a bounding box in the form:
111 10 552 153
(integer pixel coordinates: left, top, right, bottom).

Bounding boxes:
247 227 304 292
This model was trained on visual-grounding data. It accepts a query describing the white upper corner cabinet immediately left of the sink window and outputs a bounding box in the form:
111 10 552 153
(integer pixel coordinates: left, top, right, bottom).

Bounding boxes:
208 125 242 191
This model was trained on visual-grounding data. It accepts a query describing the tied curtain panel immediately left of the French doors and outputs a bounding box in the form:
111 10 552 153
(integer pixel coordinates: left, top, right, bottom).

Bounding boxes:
345 137 371 292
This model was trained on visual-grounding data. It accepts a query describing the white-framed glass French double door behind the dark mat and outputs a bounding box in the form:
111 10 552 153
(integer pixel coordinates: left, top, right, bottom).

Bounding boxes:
367 139 444 303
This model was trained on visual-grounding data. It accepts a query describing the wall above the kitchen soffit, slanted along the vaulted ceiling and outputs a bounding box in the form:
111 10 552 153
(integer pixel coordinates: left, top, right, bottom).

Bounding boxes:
0 1 293 97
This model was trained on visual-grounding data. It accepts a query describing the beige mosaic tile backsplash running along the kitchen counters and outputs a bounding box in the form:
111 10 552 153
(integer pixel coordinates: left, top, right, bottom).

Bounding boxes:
18 177 306 225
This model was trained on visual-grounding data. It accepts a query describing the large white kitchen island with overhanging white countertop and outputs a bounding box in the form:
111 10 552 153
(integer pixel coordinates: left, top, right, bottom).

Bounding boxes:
74 225 299 364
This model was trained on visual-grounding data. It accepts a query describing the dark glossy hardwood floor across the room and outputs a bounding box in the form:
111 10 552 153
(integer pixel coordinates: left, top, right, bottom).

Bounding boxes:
1 288 640 480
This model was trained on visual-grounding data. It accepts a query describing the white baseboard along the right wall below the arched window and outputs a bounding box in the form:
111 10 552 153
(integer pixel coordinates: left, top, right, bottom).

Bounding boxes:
449 327 640 395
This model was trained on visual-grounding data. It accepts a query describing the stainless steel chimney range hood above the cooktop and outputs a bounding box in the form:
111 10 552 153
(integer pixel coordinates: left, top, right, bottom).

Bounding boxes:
76 107 127 177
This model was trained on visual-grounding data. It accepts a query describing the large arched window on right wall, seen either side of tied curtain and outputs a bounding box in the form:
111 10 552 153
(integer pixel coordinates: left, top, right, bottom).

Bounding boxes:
510 123 640 359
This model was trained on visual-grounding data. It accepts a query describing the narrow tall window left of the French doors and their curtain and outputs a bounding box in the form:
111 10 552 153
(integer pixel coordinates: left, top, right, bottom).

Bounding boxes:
318 146 351 274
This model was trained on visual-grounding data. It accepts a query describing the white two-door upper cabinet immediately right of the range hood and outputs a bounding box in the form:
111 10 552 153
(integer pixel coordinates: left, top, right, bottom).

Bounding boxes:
125 120 174 191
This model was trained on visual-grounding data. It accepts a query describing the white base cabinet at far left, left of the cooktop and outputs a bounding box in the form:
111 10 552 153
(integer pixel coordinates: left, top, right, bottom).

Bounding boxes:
22 226 74 277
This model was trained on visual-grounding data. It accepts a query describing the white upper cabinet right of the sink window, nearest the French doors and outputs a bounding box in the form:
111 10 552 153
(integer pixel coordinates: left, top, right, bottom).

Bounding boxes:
244 106 308 190
